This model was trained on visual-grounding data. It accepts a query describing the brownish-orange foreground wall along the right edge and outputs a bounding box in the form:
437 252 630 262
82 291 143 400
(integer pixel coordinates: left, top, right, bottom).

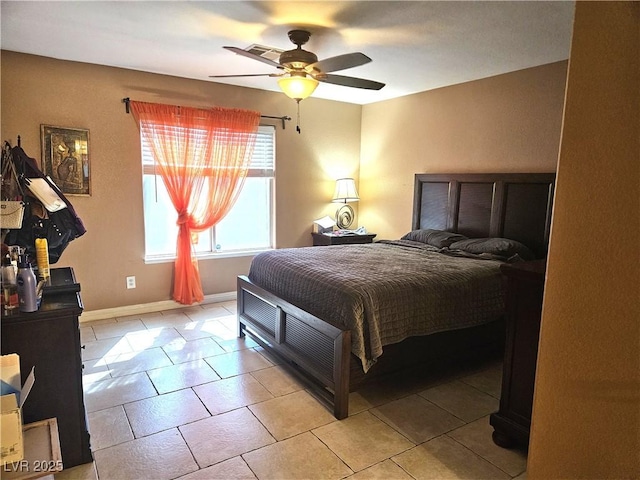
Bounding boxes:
527 2 640 480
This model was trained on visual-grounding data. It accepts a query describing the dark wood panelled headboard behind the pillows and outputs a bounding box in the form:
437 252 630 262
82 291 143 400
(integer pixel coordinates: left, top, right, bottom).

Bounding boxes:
412 173 556 258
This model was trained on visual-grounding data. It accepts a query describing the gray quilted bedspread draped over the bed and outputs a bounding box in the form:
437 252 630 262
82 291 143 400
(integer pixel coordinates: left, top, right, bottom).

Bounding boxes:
249 240 504 372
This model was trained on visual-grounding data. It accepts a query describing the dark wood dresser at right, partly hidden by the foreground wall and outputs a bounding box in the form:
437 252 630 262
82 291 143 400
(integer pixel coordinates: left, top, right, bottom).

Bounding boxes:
489 260 546 448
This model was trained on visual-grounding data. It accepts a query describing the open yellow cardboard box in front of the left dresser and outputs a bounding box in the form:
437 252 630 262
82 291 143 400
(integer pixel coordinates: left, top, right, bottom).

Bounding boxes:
0 353 35 465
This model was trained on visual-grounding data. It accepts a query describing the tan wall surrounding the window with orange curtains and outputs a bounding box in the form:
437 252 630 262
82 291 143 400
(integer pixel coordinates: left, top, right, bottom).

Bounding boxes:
1 51 361 311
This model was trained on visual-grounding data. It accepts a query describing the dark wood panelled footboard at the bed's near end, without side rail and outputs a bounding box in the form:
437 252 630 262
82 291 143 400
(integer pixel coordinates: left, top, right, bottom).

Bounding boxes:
238 276 351 419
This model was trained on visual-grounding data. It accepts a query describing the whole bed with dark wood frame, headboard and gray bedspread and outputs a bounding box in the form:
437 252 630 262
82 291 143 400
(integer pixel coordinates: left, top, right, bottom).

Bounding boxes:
237 173 555 419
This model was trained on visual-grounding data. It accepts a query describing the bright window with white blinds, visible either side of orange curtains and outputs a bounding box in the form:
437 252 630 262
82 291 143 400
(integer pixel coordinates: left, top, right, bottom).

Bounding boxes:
141 126 275 262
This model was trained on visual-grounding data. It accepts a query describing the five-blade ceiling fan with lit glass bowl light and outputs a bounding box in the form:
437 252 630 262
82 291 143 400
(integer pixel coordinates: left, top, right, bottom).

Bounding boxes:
210 30 385 103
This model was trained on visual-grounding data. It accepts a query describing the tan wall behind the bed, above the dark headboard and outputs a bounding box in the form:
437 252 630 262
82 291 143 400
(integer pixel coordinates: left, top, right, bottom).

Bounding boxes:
359 62 567 238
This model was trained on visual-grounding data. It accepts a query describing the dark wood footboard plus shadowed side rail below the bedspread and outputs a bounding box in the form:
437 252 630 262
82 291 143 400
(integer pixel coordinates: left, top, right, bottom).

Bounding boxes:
238 276 504 420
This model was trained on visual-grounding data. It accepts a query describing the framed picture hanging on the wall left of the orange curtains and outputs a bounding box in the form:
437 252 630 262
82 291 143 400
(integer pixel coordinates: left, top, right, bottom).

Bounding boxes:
40 125 91 195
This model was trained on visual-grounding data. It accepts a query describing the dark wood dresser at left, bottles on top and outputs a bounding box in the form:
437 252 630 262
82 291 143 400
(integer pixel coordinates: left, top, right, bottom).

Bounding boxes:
0 268 93 468
